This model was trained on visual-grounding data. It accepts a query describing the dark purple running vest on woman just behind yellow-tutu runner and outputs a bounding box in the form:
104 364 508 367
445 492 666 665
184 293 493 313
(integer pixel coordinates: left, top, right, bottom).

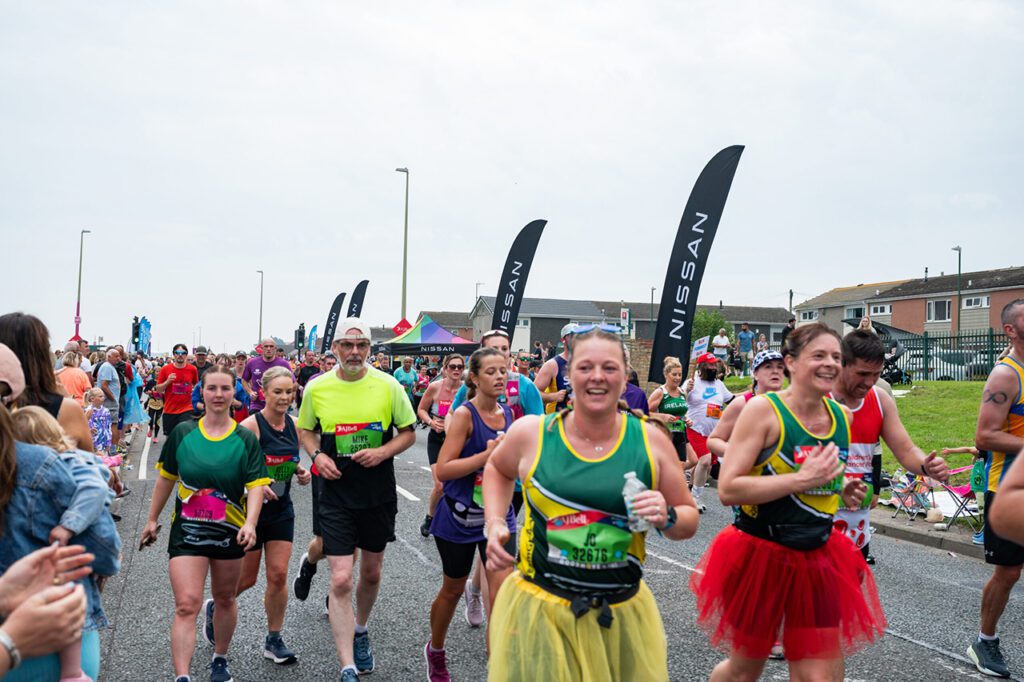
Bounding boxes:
430 402 515 544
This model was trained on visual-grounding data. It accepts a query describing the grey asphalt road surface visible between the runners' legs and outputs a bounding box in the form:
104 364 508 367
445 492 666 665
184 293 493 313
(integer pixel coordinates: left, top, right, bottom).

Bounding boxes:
101 431 1024 682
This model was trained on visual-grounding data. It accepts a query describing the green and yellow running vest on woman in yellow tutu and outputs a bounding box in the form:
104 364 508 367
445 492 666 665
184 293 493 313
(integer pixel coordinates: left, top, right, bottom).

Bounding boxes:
518 413 657 595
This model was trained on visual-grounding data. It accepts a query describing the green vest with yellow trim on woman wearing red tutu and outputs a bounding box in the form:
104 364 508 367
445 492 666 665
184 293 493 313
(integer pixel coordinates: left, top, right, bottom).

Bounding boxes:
739 392 850 525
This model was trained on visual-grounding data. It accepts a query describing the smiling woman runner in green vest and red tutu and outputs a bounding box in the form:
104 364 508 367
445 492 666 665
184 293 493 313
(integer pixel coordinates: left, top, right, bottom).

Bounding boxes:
690 324 886 682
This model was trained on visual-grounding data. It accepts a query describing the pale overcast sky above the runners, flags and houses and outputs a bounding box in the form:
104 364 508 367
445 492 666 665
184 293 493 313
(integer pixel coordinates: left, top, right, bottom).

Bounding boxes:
0 0 1024 351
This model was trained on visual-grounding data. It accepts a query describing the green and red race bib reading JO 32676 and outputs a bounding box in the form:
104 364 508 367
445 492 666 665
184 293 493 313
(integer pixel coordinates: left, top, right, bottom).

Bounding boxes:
547 510 633 569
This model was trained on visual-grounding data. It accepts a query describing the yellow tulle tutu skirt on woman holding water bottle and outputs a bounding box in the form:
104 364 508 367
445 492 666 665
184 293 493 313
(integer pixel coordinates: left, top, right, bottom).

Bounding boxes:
487 571 669 682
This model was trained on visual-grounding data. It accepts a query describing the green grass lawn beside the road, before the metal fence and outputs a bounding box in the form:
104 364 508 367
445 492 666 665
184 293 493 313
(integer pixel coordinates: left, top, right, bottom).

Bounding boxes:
725 377 985 483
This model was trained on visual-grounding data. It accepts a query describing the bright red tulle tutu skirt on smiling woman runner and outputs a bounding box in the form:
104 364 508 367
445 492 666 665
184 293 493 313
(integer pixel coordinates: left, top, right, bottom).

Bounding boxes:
690 525 886 660
